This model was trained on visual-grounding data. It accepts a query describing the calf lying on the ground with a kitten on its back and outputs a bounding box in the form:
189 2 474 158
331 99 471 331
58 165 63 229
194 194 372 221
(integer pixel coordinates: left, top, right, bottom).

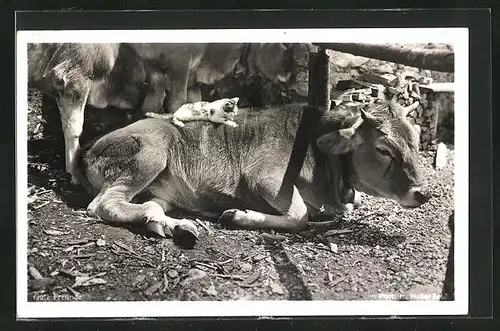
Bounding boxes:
79 103 427 246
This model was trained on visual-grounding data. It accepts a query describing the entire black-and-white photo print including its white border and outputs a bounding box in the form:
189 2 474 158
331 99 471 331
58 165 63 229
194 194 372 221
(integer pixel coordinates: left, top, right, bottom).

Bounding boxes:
16 28 469 318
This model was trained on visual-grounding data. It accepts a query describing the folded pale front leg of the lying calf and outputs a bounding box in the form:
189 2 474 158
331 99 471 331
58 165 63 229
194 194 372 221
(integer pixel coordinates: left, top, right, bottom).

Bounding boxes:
219 186 308 232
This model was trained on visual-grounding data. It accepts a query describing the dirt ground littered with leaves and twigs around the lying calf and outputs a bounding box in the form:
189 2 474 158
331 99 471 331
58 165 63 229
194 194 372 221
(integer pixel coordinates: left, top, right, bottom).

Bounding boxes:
27 90 454 301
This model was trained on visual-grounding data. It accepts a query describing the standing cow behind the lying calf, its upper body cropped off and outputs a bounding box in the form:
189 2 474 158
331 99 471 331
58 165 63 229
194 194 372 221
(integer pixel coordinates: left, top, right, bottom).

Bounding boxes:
28 43 310 183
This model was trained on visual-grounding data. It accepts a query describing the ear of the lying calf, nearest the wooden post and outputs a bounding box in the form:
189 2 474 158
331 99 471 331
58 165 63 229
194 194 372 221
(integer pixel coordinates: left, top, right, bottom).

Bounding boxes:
316 128 362 154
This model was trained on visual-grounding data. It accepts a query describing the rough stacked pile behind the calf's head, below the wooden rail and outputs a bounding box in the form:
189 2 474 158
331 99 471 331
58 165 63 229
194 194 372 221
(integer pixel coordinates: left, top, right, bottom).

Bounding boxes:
331 72 438 149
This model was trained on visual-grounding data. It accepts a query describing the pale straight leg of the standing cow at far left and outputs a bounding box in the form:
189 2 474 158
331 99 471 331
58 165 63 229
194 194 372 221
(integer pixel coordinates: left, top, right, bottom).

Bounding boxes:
56 82 90 184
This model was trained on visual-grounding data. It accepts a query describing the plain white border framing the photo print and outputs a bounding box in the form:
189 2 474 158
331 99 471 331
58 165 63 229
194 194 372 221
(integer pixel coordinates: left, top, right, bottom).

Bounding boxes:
16 28 469 319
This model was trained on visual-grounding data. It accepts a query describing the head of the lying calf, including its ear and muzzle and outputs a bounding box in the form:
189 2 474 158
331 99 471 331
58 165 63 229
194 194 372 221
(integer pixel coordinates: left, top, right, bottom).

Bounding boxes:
316 103 428 207
